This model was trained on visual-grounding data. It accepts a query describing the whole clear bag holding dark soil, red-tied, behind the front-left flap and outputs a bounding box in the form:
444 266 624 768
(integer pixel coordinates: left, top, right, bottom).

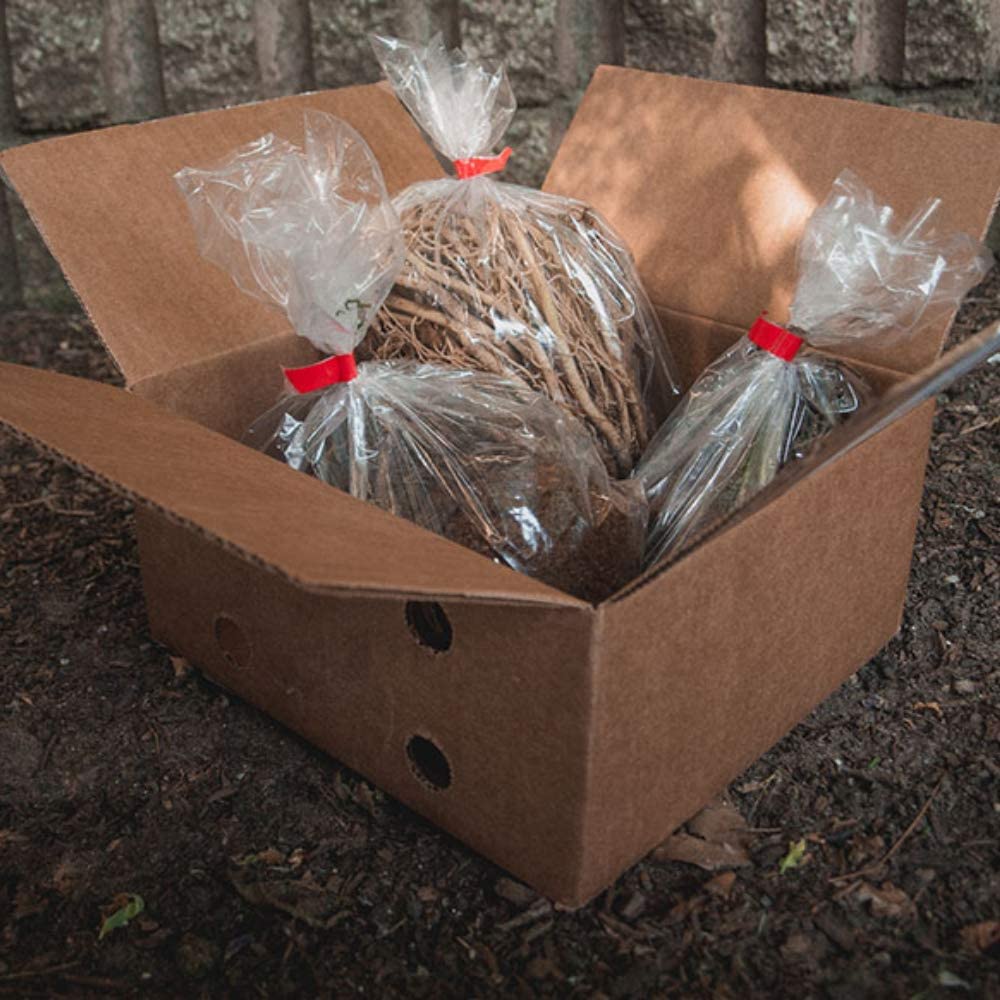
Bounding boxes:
177 112 646 600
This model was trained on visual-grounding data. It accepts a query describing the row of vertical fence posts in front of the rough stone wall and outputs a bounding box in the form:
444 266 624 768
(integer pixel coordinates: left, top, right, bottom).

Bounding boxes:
0 0 920 309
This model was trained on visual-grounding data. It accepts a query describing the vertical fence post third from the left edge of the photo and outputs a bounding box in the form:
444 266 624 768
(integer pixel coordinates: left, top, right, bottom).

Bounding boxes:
253 0 316 97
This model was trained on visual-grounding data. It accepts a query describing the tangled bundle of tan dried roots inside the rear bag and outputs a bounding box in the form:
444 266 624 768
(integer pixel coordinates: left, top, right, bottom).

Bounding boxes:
366 198 655 477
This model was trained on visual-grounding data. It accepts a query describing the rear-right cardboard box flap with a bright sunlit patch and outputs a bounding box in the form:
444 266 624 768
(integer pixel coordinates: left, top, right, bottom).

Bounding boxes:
545 66 1000 372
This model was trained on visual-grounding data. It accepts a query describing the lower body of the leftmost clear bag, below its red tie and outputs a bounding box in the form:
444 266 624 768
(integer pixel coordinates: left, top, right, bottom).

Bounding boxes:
247 361 646 601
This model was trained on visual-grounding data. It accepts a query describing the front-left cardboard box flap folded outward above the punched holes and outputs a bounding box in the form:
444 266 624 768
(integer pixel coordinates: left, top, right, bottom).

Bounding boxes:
0 364 588 608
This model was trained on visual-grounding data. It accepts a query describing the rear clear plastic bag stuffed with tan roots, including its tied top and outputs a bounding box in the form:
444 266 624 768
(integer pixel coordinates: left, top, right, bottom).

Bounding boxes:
364 36 677 476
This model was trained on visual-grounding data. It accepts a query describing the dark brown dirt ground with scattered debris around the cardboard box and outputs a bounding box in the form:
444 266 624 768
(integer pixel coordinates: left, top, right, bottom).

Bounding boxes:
0 279 1000 1000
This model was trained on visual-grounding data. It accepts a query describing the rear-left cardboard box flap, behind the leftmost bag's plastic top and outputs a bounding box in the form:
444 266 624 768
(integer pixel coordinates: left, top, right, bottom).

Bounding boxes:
0 85 441 384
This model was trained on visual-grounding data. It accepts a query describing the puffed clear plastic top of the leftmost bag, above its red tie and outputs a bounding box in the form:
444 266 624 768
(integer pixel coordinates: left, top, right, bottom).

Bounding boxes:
175 111 403 354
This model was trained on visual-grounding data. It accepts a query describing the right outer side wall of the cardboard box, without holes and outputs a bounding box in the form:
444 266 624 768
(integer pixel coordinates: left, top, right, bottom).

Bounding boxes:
580 401 933 899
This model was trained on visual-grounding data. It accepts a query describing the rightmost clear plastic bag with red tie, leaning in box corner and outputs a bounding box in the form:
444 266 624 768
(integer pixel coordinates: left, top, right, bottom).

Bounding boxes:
635 171 991 565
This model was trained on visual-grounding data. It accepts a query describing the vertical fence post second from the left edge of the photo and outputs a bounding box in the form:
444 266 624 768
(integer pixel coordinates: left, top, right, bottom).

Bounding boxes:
101 0 166 122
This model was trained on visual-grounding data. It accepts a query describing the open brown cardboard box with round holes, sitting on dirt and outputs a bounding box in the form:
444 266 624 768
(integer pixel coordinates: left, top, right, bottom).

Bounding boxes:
0 68 1000 904
